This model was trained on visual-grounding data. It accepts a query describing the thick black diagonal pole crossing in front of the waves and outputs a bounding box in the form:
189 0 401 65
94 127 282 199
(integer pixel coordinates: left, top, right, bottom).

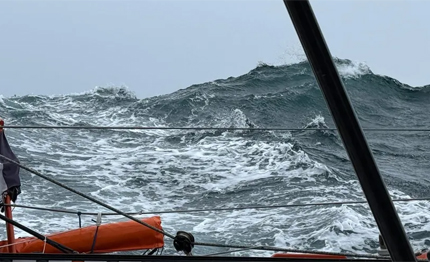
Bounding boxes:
284 0 416 261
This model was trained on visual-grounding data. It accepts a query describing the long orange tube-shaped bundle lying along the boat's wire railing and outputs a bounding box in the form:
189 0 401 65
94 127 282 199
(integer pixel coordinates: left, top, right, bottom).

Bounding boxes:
0 216 164 253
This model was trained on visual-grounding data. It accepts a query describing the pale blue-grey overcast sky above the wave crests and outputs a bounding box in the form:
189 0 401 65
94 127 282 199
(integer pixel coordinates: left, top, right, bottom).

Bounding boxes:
0 0 430 98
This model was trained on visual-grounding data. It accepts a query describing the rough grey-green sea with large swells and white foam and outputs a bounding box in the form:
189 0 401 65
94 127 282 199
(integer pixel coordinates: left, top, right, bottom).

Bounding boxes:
0 59 430 256
